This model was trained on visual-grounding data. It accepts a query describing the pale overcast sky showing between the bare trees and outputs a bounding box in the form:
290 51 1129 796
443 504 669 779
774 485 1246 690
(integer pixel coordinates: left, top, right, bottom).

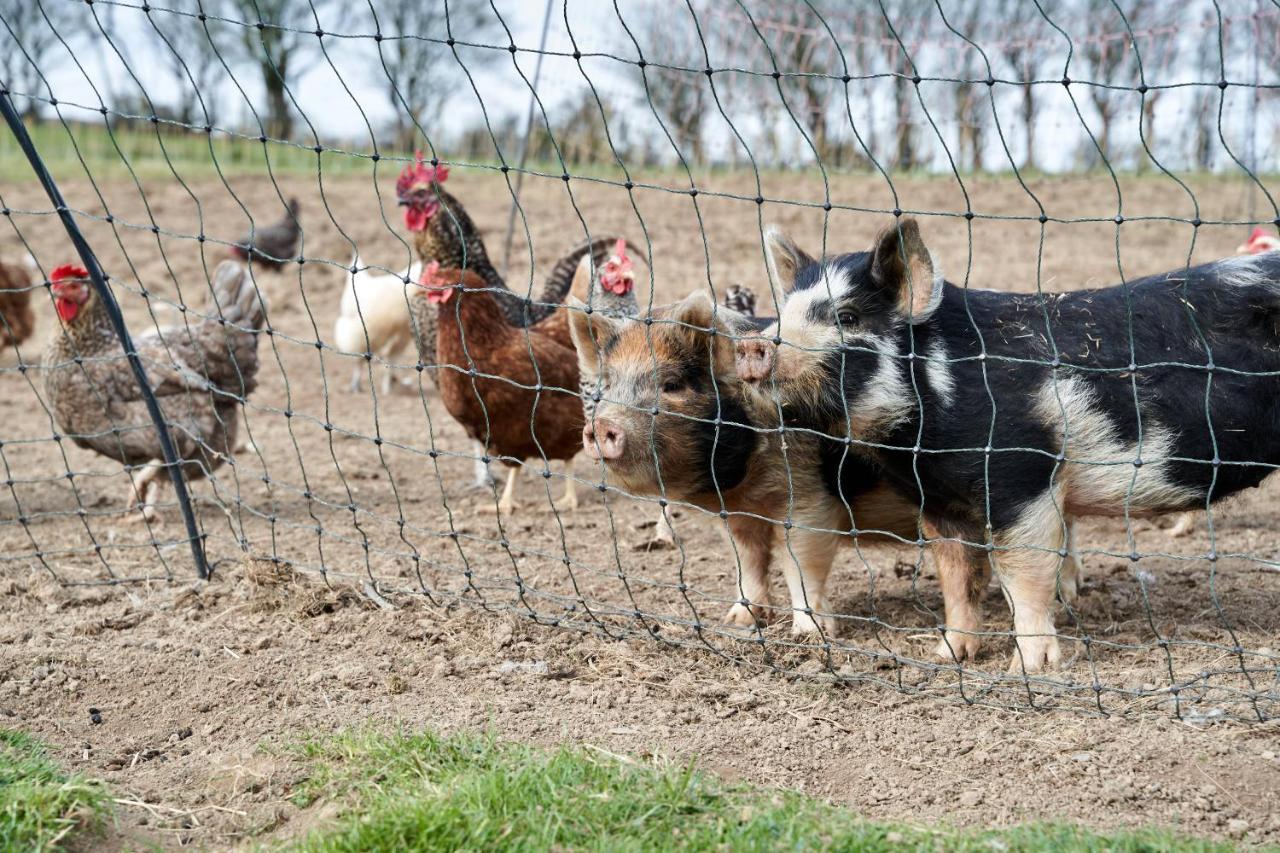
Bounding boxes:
14 0 1280 170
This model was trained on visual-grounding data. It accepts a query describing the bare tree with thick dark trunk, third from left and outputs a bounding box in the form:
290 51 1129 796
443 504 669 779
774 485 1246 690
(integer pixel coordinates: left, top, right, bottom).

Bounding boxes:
223 0 344 138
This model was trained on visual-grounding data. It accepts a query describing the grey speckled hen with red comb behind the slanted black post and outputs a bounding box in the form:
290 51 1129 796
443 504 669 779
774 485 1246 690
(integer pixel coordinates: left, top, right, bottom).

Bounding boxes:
44 261 265 521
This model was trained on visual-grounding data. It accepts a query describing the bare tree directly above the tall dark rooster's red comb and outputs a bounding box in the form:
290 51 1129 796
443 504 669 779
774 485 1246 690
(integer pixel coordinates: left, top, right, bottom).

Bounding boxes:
365 0 506 149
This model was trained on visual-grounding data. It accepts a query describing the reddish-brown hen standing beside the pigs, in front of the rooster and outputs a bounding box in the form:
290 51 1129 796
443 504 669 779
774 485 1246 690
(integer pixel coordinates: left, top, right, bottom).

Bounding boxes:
419 263 584 515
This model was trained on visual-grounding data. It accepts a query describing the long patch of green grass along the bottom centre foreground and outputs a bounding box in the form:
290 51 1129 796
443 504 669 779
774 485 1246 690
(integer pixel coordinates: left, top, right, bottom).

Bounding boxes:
287 731 1230 852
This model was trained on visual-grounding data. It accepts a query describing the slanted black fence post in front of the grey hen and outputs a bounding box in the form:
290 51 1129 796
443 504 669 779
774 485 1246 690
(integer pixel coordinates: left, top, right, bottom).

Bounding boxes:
0 91 209 580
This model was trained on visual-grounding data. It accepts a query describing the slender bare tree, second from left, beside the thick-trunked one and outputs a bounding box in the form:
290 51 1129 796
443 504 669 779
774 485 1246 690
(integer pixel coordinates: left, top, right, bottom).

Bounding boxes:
147 0 225 124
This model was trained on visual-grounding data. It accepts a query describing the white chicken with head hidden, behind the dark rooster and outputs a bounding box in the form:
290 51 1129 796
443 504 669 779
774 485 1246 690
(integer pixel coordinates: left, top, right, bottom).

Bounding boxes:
333 252 422 394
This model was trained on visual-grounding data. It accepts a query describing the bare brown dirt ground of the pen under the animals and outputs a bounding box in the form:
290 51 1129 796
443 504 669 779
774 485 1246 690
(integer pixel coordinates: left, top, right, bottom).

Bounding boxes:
0 168 1280 847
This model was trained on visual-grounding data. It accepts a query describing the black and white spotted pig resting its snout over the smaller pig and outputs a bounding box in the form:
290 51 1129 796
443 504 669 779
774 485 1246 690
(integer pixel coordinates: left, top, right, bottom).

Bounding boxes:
737 219 1280 672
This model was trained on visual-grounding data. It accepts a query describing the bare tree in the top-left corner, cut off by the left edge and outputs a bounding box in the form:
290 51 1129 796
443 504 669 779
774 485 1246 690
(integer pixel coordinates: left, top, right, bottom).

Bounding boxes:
0 0 86 119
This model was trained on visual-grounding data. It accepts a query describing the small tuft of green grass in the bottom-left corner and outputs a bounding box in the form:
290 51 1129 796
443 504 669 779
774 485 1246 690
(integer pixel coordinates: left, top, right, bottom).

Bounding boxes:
0 729 110 850
